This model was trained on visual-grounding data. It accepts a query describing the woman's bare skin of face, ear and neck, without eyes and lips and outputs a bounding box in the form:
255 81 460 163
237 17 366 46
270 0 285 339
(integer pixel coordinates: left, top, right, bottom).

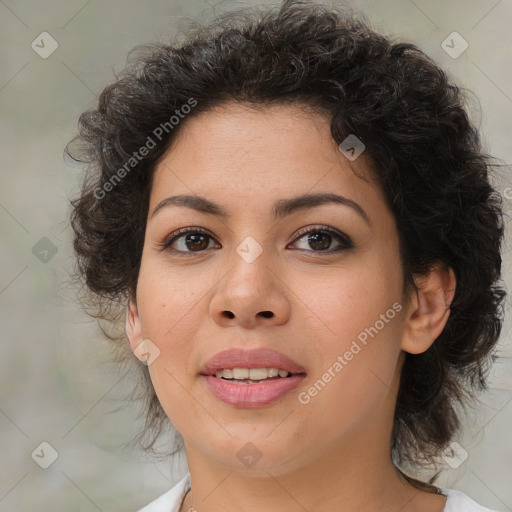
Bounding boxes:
126 103 455 512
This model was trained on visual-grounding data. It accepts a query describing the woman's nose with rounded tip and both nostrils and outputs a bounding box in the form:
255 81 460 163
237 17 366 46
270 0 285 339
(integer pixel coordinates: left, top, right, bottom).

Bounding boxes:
210 246 291 329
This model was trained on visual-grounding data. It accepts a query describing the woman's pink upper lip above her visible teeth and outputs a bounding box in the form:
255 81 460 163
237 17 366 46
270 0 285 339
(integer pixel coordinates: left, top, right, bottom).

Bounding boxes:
201 348 305 375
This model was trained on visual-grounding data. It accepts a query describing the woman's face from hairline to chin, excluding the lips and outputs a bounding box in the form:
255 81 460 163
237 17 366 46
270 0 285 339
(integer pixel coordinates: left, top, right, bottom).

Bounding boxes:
129 104 412 474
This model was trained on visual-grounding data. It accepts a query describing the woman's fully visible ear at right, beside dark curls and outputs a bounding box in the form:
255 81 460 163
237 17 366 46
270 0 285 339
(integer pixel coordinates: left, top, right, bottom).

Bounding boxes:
401 262 456 354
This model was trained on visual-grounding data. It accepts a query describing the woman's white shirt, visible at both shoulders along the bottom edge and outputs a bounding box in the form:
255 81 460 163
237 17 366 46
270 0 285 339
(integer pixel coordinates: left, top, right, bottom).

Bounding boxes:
137 473 497 512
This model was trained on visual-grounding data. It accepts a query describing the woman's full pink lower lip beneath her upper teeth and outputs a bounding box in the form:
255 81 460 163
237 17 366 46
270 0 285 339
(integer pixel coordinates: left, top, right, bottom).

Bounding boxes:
203 374 306 408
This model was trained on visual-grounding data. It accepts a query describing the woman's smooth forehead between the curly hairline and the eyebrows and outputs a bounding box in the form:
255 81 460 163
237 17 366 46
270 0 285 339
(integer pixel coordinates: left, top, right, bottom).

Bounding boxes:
150 103 382 218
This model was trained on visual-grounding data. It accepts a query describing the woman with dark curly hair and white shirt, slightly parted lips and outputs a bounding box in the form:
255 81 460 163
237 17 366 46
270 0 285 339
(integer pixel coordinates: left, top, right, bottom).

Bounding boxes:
66 1 505 512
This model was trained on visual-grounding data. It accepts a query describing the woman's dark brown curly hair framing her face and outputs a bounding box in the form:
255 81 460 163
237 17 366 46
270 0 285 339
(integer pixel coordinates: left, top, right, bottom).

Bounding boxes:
65 1 506 488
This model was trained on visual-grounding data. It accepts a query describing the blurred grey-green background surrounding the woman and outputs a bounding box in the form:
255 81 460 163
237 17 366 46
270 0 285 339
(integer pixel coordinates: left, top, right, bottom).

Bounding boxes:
0 0 512 512
